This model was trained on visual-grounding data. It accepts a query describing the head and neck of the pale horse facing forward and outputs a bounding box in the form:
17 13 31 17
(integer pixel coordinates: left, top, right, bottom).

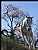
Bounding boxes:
22 16 33 31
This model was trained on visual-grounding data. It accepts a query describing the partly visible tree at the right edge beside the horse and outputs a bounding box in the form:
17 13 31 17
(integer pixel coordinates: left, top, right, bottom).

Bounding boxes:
32 18 38 47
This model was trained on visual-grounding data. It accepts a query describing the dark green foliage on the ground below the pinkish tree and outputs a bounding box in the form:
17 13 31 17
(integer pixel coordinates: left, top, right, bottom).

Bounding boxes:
1 36 25 50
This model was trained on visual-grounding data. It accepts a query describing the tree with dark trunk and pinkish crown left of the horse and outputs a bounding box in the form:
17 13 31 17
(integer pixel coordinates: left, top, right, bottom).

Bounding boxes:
1 4 29 37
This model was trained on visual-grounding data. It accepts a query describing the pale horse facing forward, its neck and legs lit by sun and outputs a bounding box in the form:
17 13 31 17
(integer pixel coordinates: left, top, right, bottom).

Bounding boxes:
21 16 33 49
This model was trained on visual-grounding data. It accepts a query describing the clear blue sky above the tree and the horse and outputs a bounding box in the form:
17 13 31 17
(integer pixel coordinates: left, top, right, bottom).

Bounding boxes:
1 1 38 35
